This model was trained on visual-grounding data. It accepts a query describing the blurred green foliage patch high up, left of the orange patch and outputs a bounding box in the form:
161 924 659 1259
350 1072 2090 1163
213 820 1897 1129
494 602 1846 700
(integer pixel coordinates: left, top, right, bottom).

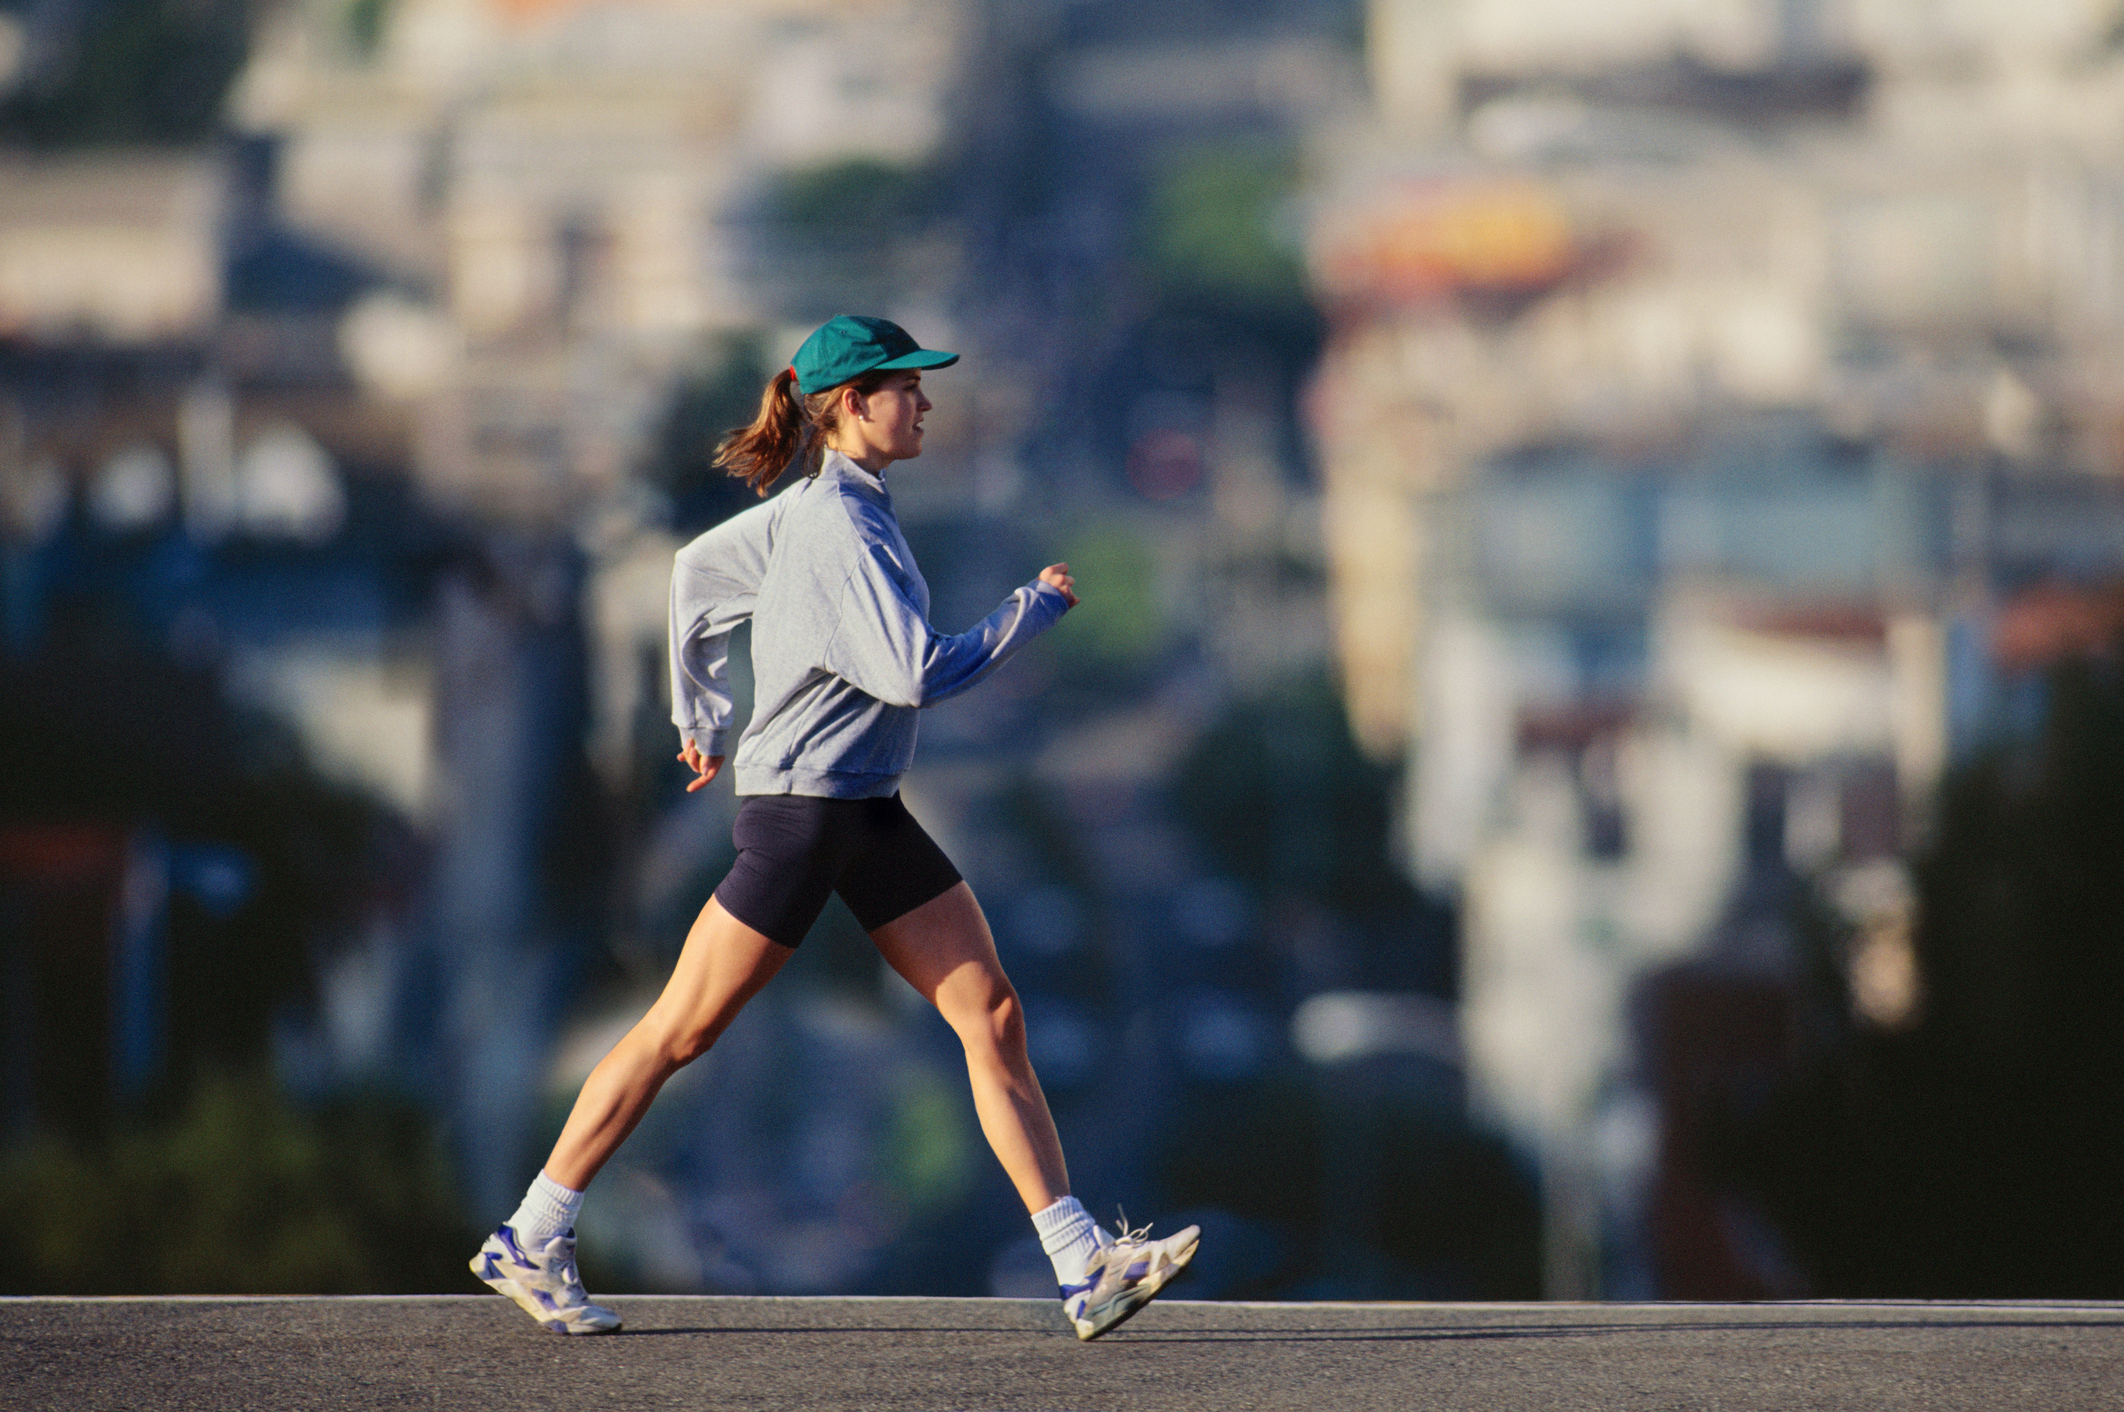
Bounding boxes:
1141 144 1308 314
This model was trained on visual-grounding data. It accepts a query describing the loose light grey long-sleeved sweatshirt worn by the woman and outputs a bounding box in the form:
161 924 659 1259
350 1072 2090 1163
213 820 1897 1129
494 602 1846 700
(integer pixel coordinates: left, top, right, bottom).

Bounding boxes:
671 450 1068 798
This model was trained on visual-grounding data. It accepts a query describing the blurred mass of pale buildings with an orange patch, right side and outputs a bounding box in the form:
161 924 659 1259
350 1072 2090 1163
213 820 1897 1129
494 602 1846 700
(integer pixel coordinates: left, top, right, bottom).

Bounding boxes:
1311 0 2124 1295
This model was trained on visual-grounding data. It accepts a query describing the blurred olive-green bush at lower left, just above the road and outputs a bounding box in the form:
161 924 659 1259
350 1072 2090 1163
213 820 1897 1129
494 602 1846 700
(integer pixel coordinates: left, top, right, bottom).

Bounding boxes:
0 1077 476 1295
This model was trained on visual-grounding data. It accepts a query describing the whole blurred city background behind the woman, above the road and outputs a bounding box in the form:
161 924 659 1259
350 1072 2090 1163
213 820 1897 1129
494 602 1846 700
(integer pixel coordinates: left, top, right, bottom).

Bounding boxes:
0 0 2124 1299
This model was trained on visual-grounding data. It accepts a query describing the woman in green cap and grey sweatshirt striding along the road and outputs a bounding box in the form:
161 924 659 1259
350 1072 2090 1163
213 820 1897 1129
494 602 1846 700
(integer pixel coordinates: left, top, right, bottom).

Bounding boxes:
472 314 1200 1338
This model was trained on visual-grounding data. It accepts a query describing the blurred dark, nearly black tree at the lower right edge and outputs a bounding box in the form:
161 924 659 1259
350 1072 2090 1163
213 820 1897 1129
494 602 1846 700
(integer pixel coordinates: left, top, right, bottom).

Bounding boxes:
1710 636 2124 1297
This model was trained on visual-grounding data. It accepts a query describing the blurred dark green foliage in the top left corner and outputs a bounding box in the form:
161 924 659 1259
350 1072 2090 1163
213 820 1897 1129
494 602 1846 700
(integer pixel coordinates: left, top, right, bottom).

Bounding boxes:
0 0 251 147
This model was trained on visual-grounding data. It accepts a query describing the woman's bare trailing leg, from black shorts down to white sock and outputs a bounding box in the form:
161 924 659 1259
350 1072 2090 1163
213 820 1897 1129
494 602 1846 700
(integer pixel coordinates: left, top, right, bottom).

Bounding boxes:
546 898 797 1191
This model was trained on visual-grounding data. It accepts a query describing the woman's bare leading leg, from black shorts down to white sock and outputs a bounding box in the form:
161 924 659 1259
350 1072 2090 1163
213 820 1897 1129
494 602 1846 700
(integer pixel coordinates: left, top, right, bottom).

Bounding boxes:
866 883 1068 1212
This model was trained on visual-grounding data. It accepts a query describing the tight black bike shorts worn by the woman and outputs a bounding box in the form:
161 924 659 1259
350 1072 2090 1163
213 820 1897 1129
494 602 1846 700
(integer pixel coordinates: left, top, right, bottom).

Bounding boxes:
716 794 960 947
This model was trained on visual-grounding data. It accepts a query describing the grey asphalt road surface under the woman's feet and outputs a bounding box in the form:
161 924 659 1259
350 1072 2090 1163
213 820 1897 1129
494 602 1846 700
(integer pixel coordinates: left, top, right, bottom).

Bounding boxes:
0 1295 2124 1412
